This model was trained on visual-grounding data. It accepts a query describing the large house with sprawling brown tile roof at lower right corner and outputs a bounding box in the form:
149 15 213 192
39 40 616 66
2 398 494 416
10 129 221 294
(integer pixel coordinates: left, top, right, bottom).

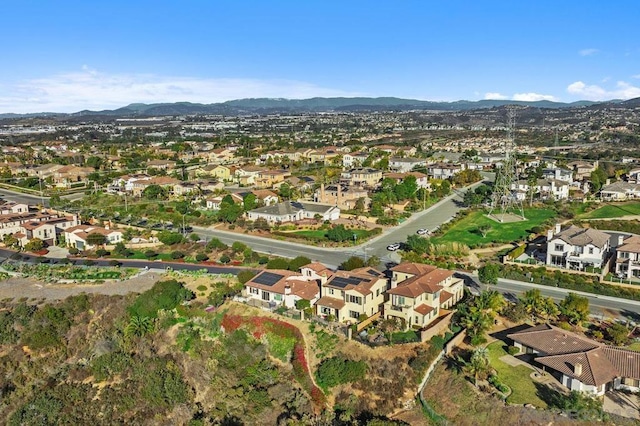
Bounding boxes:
507 324 640 395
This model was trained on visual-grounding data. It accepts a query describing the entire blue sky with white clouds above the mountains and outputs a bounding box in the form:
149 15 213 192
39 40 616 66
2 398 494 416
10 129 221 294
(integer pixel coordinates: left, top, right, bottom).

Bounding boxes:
0 0 640 112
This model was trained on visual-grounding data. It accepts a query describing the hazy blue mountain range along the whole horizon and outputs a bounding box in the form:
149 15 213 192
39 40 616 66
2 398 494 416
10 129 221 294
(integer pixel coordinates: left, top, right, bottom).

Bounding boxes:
0 97 640 119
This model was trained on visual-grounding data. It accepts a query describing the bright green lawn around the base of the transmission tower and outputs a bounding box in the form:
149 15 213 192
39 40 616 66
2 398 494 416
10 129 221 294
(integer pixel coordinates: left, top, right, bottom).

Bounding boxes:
431 209 556 247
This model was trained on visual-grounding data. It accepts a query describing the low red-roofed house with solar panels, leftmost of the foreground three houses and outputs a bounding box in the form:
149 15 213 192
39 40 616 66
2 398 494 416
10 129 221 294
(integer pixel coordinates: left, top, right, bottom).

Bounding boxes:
244 269 320 308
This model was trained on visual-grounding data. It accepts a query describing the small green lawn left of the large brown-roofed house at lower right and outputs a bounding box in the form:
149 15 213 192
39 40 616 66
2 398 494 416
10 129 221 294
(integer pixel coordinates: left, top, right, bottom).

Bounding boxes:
487 340 547 408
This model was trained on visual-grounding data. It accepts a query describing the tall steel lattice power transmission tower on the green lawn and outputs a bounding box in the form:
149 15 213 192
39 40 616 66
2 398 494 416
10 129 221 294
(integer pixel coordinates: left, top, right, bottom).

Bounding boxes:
489 107 525 223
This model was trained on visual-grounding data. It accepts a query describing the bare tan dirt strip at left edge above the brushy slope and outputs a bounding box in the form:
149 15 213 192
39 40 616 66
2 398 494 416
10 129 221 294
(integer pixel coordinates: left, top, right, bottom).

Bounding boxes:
0 272 163 300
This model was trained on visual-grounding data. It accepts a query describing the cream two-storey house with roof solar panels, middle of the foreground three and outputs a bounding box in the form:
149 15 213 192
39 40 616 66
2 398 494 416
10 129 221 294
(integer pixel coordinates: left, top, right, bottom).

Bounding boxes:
316 267 388 322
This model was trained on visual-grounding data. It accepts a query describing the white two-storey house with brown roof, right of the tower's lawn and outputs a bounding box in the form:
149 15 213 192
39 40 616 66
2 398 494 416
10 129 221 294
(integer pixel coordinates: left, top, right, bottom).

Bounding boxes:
546 225 611 271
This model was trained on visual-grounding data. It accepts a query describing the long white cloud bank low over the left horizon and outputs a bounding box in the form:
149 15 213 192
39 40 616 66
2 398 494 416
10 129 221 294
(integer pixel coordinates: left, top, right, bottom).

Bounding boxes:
0 65 362 113
